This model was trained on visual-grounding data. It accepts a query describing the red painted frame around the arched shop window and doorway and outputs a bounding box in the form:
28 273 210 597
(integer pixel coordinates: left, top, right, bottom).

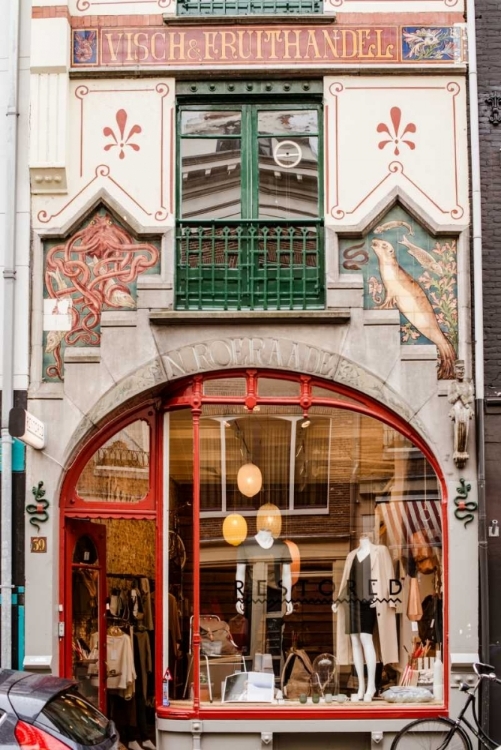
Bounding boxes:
60 369 449 720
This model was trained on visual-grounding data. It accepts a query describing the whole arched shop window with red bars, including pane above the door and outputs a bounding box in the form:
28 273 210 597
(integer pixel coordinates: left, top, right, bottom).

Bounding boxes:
61 371 447 716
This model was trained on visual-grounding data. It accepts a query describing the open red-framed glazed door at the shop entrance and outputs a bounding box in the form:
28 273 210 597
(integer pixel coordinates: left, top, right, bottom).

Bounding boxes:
64 519 106 711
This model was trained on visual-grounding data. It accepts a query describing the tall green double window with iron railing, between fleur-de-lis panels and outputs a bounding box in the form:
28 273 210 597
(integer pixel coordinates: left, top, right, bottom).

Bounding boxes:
176 92 324 310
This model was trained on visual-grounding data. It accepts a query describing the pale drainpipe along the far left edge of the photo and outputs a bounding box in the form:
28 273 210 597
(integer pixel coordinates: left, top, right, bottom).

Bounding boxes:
0 0 20 669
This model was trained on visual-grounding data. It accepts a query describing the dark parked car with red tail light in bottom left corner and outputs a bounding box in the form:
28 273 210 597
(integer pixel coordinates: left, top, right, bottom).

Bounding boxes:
0 669 118 750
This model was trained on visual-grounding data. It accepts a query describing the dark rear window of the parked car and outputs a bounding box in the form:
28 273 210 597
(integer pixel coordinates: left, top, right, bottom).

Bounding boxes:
37 692 110 745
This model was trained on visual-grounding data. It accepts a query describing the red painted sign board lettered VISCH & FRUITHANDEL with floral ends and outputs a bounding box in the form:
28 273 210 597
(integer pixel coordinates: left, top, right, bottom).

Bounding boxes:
72 23 464 68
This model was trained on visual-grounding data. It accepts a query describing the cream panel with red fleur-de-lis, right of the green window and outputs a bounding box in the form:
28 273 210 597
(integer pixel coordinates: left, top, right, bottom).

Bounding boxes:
326 76 468 228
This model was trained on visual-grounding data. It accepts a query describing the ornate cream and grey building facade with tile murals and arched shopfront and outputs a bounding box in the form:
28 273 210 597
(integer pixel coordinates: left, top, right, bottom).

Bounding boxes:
25 0 478 749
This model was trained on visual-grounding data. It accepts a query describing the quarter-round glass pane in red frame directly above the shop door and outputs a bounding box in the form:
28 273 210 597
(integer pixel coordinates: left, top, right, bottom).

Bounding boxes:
76 420 150 503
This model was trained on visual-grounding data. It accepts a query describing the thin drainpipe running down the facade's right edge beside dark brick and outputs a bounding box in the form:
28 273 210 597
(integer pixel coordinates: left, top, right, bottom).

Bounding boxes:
466 0 490 730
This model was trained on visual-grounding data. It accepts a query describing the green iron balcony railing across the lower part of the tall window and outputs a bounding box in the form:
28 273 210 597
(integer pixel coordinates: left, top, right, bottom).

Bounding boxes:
176 220 325 310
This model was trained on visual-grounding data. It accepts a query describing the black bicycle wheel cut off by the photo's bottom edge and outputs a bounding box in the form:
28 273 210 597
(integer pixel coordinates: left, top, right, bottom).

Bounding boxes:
391 719 471 750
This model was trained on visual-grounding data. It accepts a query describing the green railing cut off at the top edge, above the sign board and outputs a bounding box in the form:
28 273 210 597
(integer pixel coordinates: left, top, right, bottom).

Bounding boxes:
177 0 323 16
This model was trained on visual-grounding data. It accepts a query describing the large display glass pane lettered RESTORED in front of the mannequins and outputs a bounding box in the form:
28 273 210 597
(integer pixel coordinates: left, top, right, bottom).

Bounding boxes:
170 394 444 711
